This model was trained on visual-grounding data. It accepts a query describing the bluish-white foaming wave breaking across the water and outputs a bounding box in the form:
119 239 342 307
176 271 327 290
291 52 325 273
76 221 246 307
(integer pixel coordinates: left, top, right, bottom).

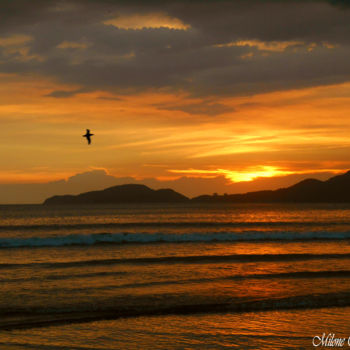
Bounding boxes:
0 231 350 248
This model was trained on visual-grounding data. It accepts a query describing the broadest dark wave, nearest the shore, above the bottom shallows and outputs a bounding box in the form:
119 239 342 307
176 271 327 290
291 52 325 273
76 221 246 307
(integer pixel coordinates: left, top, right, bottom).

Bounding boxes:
0 292 350 330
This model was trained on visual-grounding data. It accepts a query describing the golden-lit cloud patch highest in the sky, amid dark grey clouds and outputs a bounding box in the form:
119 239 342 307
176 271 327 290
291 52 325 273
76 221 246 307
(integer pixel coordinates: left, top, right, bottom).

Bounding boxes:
103 12 190 30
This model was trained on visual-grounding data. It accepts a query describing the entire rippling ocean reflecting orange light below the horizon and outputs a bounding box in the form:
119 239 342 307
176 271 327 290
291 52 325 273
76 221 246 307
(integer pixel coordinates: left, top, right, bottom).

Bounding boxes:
0 203 350 350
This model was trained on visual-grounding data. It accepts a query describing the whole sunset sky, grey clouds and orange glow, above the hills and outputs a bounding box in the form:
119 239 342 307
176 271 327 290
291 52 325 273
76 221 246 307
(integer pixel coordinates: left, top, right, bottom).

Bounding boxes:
0 0 350 200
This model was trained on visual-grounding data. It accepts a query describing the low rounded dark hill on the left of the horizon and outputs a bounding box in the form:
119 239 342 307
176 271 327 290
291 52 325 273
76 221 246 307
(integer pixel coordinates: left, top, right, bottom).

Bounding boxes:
44 184 189 205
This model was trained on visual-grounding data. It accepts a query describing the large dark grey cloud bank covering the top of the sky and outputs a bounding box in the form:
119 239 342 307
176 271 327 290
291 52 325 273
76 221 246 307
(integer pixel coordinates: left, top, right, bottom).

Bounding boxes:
0 0 350 97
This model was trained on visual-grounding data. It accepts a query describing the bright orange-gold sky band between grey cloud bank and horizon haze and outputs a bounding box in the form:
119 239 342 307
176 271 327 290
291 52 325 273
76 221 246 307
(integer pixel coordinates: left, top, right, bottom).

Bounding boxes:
0 75 350 183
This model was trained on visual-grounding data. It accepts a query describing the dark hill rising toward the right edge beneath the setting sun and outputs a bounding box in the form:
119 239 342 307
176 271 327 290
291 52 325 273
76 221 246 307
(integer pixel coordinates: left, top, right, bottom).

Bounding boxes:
192 171 350 203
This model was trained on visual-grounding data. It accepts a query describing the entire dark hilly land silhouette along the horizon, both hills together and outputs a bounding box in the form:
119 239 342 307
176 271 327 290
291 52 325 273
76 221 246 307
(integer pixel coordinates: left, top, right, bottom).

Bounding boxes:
44 171 350 205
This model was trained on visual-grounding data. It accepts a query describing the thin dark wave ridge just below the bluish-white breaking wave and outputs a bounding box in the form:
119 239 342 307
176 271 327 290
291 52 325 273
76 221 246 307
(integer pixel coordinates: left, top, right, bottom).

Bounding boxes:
0 253 350 269
